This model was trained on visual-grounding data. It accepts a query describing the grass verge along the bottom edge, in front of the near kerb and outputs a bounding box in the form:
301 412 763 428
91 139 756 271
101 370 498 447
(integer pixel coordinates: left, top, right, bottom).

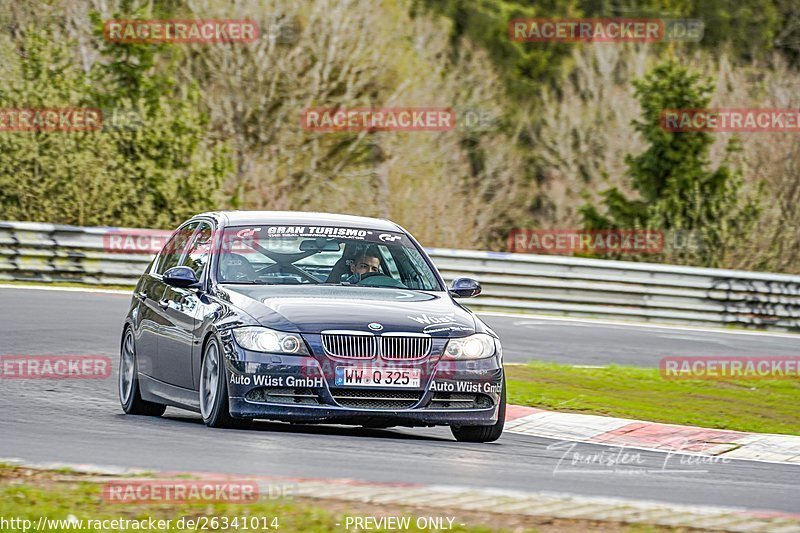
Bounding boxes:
0 464 668 533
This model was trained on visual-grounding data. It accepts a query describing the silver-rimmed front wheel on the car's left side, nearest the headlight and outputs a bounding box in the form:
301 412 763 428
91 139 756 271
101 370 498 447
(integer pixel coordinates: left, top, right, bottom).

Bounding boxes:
200 337 252 428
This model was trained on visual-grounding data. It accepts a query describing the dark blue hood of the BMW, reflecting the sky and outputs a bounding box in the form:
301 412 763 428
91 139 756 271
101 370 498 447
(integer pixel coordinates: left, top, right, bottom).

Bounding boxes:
221 285 476 337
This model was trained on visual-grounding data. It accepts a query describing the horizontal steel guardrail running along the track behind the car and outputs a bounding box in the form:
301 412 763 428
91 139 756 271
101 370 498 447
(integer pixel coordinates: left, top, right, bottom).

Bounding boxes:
0 222 800 331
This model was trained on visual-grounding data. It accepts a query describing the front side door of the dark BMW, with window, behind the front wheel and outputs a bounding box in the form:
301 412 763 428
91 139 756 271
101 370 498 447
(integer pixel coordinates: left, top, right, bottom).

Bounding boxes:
158 221 213 389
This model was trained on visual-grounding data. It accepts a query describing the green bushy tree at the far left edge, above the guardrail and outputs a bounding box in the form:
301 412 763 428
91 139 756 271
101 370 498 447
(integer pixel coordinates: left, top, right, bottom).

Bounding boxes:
0 28 136 224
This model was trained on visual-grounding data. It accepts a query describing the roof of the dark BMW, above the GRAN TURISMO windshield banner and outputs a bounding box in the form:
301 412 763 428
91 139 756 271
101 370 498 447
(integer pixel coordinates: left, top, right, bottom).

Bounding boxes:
197 211 403 231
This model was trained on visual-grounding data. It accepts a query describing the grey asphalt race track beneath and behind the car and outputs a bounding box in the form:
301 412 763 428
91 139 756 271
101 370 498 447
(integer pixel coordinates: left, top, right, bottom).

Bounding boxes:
0 289 800 512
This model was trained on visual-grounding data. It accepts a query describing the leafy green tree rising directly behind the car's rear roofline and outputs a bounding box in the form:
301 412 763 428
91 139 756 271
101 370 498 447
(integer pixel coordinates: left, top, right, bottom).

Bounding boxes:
92 8 233 228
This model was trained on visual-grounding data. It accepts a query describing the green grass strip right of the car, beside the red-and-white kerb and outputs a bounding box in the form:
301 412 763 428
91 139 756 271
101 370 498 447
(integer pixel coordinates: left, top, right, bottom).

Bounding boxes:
506 362 800 435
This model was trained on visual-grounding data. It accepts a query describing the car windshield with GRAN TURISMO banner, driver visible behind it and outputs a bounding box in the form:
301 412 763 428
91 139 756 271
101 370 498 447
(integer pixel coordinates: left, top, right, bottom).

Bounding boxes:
217 226 443 291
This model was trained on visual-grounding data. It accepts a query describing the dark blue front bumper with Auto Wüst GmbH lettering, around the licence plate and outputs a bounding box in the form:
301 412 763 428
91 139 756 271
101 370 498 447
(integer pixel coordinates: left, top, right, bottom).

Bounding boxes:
223 334 503 427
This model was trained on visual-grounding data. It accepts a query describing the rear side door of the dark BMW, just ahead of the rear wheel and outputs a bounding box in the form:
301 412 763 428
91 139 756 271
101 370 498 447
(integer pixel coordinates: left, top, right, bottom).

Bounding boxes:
147 222 199 381
